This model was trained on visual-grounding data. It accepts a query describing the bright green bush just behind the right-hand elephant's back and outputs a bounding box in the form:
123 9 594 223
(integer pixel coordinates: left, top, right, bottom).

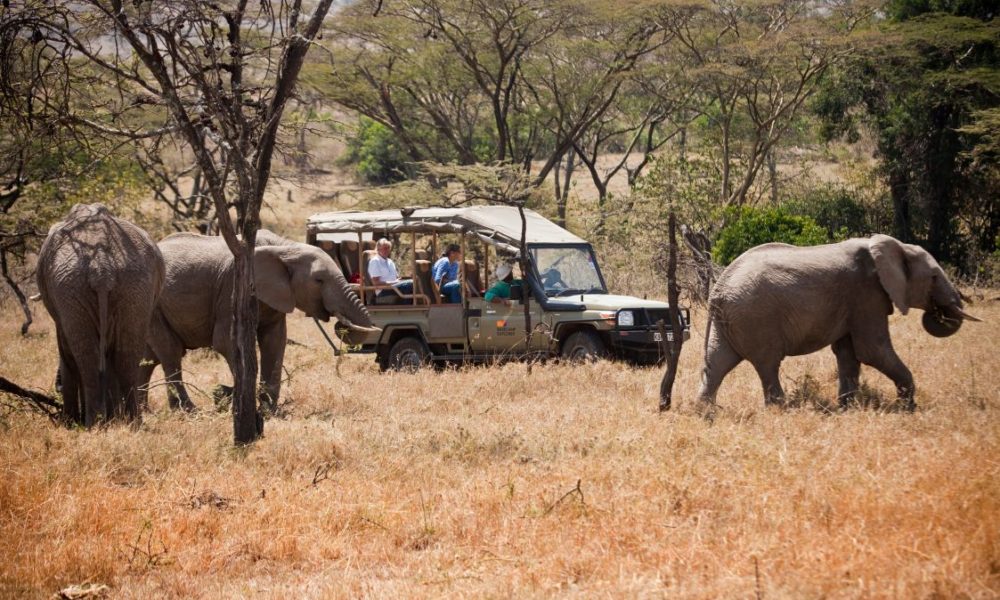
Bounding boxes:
712 207 827 265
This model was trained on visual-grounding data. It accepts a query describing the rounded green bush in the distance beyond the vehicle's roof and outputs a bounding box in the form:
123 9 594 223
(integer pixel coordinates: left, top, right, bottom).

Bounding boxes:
343 117 410 185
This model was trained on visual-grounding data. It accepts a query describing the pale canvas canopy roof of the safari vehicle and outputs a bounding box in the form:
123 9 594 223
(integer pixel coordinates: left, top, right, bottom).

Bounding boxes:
306 206 588 254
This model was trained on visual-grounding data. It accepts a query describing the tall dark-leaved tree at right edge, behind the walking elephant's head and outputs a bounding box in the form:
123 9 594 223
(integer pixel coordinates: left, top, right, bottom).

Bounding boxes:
817 0 1000 266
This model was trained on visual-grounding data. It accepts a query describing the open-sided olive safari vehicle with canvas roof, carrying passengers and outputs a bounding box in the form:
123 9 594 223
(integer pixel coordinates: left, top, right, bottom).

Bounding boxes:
306 206 689 370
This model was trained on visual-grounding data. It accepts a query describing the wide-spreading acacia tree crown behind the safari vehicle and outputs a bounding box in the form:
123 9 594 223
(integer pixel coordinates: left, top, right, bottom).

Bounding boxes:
328 0 663 185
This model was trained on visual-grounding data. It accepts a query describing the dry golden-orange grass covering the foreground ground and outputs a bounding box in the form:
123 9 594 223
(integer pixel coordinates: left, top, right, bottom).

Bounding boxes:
0 296 1000 598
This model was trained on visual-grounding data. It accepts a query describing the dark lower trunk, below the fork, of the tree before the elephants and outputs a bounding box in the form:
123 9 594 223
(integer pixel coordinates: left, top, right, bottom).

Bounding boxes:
230 227 264 445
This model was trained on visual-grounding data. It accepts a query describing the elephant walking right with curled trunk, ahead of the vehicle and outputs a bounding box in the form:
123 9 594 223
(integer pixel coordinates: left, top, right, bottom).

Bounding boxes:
699 235 979 412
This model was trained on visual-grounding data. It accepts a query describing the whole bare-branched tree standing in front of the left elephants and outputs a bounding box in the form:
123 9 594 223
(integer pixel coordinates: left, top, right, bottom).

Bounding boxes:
0 0 332 444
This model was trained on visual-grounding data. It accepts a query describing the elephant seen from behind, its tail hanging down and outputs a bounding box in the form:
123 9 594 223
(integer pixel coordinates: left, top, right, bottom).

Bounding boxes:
37 204 165 427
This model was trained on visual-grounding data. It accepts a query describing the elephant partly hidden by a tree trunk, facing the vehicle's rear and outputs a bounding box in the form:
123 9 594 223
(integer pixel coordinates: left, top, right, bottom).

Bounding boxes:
141 230 372 409
